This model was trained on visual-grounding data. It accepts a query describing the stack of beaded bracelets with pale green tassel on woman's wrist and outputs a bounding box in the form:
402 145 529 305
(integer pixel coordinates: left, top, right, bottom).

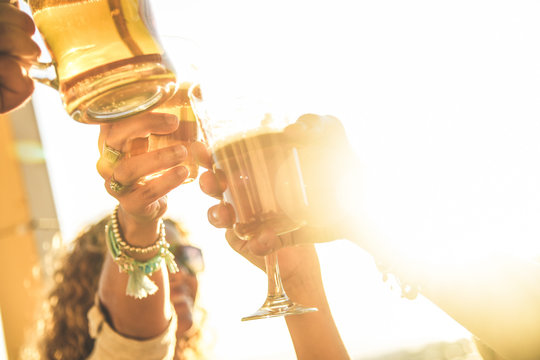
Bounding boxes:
105 208 178 299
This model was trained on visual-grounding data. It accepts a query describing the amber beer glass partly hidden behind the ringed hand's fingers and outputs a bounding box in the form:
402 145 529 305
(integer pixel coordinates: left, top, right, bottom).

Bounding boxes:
149 82 200 183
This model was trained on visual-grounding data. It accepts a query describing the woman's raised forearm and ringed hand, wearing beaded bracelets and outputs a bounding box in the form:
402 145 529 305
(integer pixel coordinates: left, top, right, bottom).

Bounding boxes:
93 114 187 339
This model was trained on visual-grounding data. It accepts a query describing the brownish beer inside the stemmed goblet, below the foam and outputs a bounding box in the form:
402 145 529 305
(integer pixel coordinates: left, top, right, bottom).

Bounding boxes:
213 132 307 239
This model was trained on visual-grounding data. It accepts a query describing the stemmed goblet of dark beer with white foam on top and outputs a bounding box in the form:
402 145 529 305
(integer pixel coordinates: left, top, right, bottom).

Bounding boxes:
190 86 317 321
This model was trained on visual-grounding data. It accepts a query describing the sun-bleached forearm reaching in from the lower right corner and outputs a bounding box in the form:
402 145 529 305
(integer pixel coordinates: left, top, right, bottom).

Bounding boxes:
354 228 540 360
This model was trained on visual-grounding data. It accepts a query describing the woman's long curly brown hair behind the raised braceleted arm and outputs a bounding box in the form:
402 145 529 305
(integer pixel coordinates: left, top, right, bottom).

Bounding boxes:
22 217 205 360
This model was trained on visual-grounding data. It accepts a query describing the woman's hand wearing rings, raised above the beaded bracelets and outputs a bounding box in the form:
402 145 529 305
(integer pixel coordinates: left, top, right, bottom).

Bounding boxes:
97 113 189 246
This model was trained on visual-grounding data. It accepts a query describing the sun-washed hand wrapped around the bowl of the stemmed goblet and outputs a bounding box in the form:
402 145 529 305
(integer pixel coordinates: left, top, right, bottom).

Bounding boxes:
192 114 359 255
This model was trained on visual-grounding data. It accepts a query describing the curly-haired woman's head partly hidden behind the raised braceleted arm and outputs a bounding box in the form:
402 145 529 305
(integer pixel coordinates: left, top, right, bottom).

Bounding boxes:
25 217 205 360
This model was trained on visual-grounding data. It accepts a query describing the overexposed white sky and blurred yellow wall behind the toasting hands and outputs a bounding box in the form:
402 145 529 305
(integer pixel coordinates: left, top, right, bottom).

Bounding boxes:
0 0 540 360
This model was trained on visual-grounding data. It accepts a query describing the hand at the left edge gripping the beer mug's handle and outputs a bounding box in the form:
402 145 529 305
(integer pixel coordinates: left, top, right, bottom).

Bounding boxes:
0 0 41 113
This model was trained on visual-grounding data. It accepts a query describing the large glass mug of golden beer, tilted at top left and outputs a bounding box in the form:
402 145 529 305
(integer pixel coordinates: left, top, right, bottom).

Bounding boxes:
29 0 176 123
